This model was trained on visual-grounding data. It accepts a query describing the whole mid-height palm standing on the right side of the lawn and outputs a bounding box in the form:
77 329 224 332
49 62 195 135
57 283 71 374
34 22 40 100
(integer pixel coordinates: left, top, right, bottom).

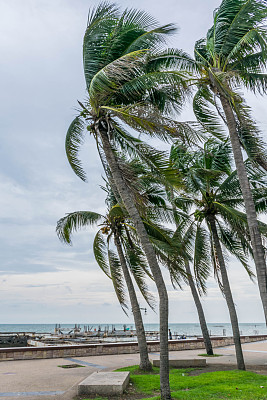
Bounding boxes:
173 141 267 369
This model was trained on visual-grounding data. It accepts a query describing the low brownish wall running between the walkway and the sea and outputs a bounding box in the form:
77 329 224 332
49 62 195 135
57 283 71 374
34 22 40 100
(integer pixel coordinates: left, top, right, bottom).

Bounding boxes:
0 335 267 361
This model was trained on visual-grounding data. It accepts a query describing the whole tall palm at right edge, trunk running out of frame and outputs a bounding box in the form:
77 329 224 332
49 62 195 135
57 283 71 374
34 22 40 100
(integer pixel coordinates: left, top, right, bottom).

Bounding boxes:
176 0 267 322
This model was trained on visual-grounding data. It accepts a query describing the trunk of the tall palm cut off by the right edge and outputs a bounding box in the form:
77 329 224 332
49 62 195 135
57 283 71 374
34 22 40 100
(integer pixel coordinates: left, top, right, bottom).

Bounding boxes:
220 90 267 323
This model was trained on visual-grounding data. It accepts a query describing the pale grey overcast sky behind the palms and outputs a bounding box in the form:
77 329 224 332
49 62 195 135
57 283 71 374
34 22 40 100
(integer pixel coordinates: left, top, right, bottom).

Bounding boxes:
0 0 267 324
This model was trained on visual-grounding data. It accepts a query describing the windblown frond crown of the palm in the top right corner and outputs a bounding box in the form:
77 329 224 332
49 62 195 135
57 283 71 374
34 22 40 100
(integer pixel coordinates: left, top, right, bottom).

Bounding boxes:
192 0 267 170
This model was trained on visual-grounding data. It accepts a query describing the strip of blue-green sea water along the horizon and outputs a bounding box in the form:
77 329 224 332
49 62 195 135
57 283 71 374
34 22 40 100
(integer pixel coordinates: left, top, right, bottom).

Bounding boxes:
0 322 267 336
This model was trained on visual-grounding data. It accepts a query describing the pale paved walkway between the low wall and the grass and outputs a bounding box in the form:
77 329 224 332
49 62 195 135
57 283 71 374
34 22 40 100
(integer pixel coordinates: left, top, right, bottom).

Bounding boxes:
0 341 267 400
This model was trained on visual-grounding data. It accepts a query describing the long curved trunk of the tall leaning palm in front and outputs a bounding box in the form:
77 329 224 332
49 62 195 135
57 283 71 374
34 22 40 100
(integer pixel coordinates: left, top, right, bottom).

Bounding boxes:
96 126 171 400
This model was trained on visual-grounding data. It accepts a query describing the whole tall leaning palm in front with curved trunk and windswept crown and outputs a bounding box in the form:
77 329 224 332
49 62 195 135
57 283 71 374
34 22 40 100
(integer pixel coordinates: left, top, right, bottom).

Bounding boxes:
66 2 191 400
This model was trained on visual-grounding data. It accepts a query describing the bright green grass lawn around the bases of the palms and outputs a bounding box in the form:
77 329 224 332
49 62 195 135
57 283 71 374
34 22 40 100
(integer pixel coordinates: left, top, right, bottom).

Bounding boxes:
84 366 267 400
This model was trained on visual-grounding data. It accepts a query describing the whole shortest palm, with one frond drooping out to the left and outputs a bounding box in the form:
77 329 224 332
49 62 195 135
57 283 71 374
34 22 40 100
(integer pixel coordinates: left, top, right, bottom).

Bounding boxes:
56 205 153 371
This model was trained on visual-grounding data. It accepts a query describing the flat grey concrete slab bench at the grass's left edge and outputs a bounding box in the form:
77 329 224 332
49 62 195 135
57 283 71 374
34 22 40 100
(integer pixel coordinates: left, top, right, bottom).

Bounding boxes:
78 371 130 396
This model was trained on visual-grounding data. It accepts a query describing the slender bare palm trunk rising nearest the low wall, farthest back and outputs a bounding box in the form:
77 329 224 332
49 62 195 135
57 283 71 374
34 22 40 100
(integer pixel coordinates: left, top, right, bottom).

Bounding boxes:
185 260 213 356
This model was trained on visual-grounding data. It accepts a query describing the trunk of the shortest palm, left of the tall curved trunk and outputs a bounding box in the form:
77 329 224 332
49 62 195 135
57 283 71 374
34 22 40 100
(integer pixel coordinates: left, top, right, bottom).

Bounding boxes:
114 235 152 371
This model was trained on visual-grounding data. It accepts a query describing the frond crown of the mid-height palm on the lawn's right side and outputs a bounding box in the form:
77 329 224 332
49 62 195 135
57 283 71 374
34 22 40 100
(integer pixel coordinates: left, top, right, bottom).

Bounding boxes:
172 140 267 291
